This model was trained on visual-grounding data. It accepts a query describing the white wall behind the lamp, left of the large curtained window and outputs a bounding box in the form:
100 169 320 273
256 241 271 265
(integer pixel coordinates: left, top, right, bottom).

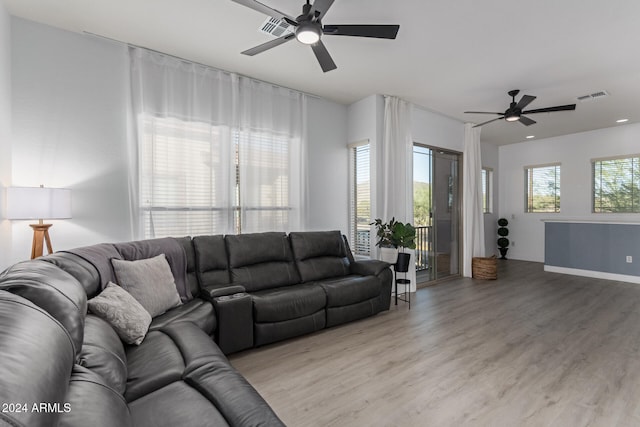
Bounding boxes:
11 17 130 268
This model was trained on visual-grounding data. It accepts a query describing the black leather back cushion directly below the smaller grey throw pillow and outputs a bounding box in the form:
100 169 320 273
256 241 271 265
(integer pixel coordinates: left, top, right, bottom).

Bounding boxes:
78 314 127 394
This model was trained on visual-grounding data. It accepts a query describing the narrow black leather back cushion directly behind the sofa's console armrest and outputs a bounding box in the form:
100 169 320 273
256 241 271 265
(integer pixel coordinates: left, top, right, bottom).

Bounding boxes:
193 235 231 287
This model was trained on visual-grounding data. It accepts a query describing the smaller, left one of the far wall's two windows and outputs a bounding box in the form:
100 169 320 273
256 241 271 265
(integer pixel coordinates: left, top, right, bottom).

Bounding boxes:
525 164 560 213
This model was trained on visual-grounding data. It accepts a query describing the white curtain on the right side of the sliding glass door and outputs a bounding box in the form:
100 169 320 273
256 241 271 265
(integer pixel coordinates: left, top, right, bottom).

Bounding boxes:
462 123 485 277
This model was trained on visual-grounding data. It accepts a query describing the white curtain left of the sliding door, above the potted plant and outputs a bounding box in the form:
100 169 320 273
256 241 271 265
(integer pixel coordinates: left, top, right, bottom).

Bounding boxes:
377 96 413 223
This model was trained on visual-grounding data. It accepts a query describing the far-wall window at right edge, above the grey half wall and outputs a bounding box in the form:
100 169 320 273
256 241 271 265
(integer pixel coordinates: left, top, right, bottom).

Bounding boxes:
591 156 640 213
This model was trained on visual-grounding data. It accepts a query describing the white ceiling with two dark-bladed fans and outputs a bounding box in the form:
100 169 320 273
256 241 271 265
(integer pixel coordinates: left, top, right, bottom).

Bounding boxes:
3 0 640 144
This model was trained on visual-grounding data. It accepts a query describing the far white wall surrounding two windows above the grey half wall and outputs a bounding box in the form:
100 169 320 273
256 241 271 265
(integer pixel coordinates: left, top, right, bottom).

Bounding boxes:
499 124 640 262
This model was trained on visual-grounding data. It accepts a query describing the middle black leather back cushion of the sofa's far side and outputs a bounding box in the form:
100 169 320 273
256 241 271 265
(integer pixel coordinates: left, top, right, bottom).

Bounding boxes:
225 232 300 292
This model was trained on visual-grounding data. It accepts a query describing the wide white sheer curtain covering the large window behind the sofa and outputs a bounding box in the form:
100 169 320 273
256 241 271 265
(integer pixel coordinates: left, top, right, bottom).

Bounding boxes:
129 47 306 238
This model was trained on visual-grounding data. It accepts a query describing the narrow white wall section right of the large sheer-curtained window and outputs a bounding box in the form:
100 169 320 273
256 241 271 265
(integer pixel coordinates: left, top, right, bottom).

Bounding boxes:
307 97 349 234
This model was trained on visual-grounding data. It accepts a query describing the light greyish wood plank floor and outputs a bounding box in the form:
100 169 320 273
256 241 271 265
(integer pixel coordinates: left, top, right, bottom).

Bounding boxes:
230 260 640 427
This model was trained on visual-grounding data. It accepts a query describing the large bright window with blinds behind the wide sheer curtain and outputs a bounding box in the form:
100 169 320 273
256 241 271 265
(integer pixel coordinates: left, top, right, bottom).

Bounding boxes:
139 115 292 238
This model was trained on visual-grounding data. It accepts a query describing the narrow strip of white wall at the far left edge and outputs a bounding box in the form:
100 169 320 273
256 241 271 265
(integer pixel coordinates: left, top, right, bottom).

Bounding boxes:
0 0 12 271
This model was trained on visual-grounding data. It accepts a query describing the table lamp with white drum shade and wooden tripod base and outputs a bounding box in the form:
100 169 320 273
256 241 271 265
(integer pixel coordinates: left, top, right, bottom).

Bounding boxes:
7 186 71 259
